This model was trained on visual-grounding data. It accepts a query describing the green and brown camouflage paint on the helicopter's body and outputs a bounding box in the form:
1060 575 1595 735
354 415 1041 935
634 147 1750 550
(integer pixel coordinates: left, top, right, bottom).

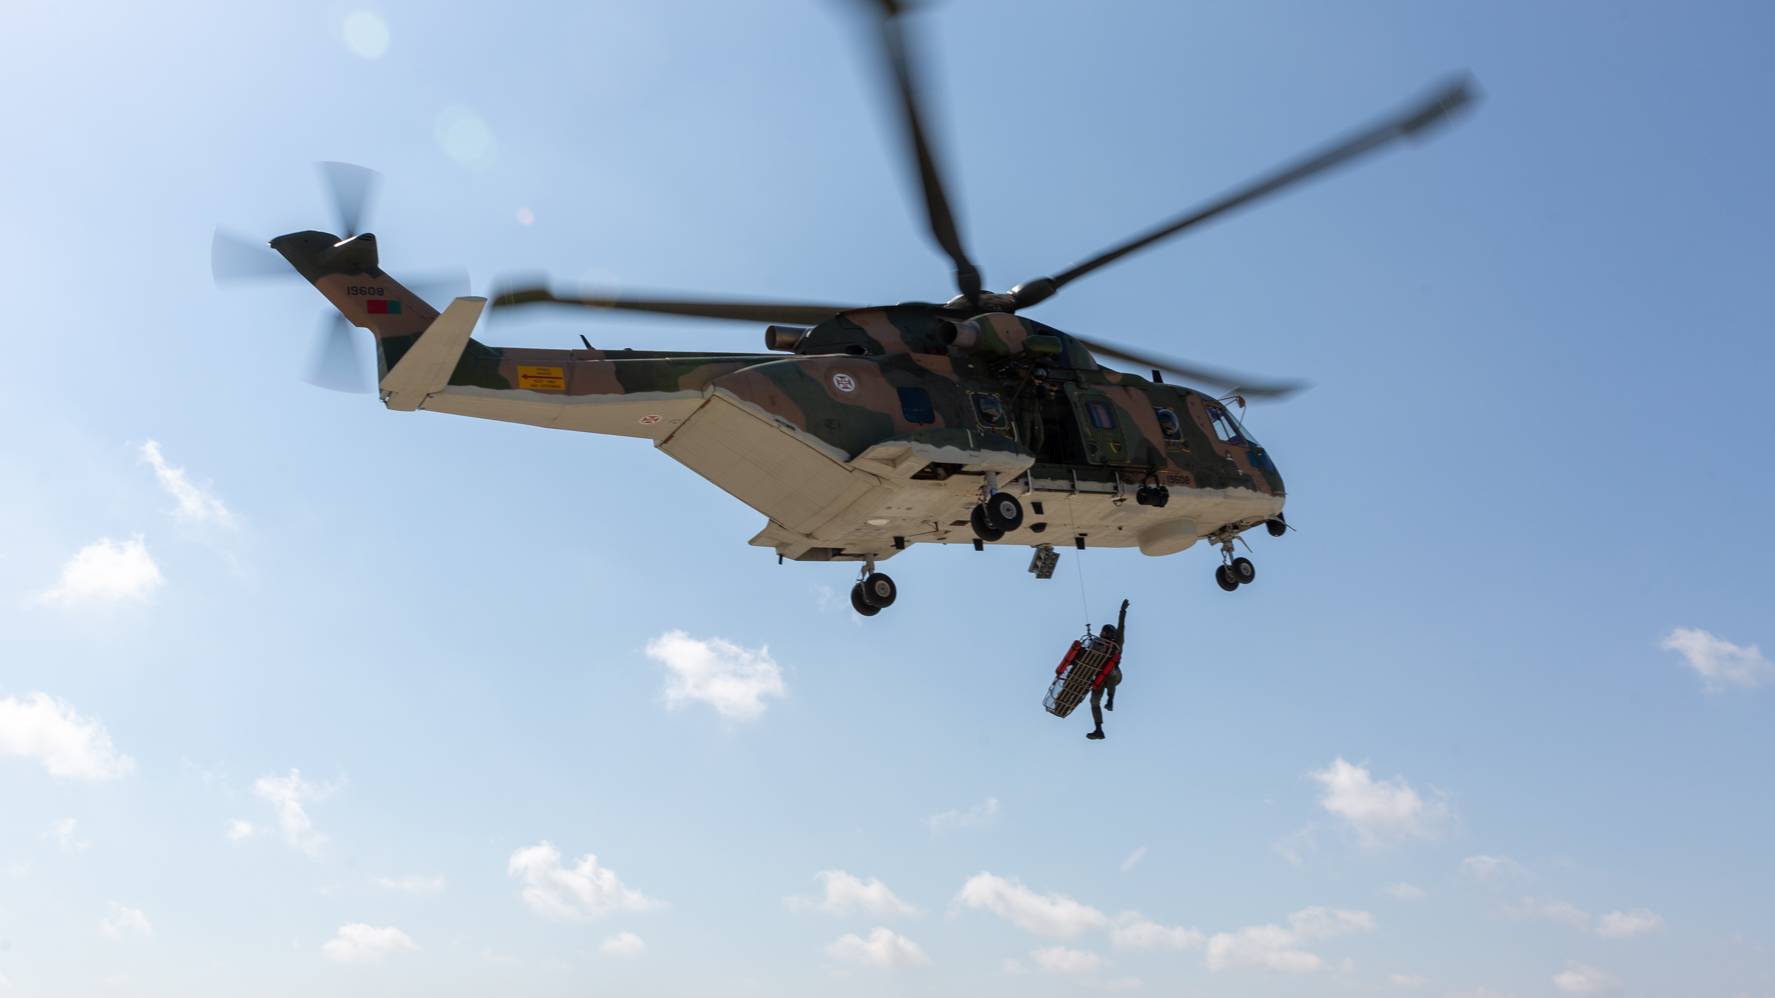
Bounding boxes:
272 233 1285 558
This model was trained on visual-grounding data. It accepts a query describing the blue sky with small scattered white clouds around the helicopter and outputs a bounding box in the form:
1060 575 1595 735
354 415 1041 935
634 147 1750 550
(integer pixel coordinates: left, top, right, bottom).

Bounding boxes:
0 0 1775 996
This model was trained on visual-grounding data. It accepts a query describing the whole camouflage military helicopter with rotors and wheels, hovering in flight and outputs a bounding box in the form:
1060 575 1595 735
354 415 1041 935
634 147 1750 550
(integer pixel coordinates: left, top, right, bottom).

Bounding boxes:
213 0 1473 616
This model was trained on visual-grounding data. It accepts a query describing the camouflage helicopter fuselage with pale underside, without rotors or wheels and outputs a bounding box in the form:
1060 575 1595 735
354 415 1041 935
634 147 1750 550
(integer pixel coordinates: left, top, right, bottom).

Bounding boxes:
272 233 1285 561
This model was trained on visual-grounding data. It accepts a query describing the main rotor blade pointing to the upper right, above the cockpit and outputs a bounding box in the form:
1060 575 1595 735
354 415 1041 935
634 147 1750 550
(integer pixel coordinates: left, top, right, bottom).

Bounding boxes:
1012 76 1477 307
